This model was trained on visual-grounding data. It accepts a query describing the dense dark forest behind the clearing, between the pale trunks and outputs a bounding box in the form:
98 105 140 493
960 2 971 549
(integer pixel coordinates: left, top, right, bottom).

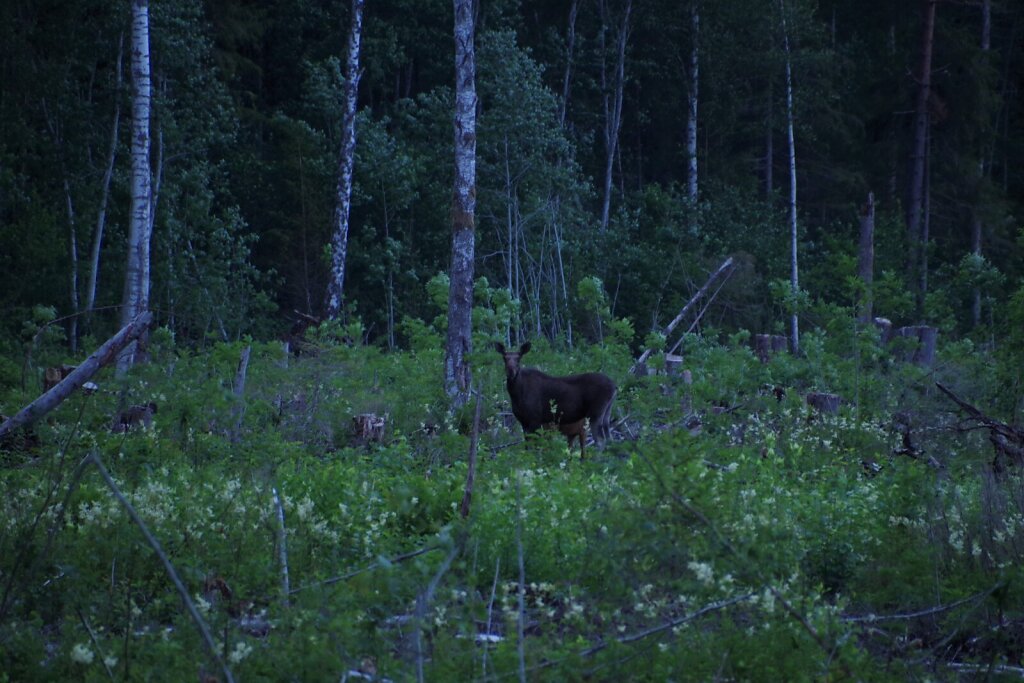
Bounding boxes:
0 0 1024 347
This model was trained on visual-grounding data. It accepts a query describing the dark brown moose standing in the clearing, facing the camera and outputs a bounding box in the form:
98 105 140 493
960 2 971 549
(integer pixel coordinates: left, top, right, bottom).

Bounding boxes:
495 342 615 459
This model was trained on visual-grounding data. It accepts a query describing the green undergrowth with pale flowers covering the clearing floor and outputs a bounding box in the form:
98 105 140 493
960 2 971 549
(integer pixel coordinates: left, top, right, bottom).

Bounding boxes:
0 335 1024 681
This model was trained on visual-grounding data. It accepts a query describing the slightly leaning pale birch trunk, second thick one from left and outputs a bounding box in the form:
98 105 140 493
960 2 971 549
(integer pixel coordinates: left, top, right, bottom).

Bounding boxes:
324 0 364 318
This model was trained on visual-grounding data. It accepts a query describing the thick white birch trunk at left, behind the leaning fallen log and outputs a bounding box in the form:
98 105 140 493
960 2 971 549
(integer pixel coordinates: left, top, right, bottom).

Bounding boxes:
118 0 153 373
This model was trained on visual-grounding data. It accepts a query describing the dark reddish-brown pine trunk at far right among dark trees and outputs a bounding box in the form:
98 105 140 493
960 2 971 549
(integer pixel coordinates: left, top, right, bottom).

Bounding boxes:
906 0 938 317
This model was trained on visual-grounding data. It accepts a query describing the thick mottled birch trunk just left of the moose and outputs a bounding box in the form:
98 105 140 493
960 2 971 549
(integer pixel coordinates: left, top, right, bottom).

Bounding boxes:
444 0 476 407
